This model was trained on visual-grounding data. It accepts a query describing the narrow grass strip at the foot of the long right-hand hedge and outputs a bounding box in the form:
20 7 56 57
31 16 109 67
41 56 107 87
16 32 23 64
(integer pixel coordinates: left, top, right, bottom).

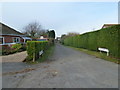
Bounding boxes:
67 46 120 64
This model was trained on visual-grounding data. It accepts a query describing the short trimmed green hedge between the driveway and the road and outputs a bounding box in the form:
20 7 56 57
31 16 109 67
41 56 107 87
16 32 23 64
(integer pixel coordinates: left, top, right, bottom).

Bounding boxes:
27 41 48 60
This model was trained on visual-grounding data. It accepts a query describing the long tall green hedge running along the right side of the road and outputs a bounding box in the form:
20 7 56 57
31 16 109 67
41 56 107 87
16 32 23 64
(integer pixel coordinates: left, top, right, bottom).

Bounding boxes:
64 25 120 58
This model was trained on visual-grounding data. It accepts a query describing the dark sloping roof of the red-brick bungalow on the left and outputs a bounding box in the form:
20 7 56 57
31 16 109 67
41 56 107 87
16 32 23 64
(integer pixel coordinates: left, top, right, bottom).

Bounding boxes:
0 23 24 35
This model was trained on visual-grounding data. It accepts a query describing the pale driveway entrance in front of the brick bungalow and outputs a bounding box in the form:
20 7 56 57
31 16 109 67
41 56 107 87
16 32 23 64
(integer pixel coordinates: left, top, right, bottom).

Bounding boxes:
0 51 28 73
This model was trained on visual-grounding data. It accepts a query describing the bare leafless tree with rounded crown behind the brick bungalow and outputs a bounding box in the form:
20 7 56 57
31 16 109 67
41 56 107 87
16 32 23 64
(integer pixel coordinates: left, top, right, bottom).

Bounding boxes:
24 22 42 37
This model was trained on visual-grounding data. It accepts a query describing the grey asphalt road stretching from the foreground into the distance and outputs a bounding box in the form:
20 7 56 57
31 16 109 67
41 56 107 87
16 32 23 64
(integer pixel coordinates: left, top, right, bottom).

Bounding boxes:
3 44 118 88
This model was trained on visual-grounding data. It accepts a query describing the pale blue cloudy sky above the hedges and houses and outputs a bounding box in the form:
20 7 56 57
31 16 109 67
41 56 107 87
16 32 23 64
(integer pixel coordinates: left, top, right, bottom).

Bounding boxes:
0 2 118 36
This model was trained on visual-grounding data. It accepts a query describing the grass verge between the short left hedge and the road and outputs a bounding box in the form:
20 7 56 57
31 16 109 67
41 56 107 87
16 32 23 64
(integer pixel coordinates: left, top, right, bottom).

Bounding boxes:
26 45 55 64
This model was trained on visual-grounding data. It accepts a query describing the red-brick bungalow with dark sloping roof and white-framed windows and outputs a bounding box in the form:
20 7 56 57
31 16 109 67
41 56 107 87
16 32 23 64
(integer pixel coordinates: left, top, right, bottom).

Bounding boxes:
0 23 32 46
